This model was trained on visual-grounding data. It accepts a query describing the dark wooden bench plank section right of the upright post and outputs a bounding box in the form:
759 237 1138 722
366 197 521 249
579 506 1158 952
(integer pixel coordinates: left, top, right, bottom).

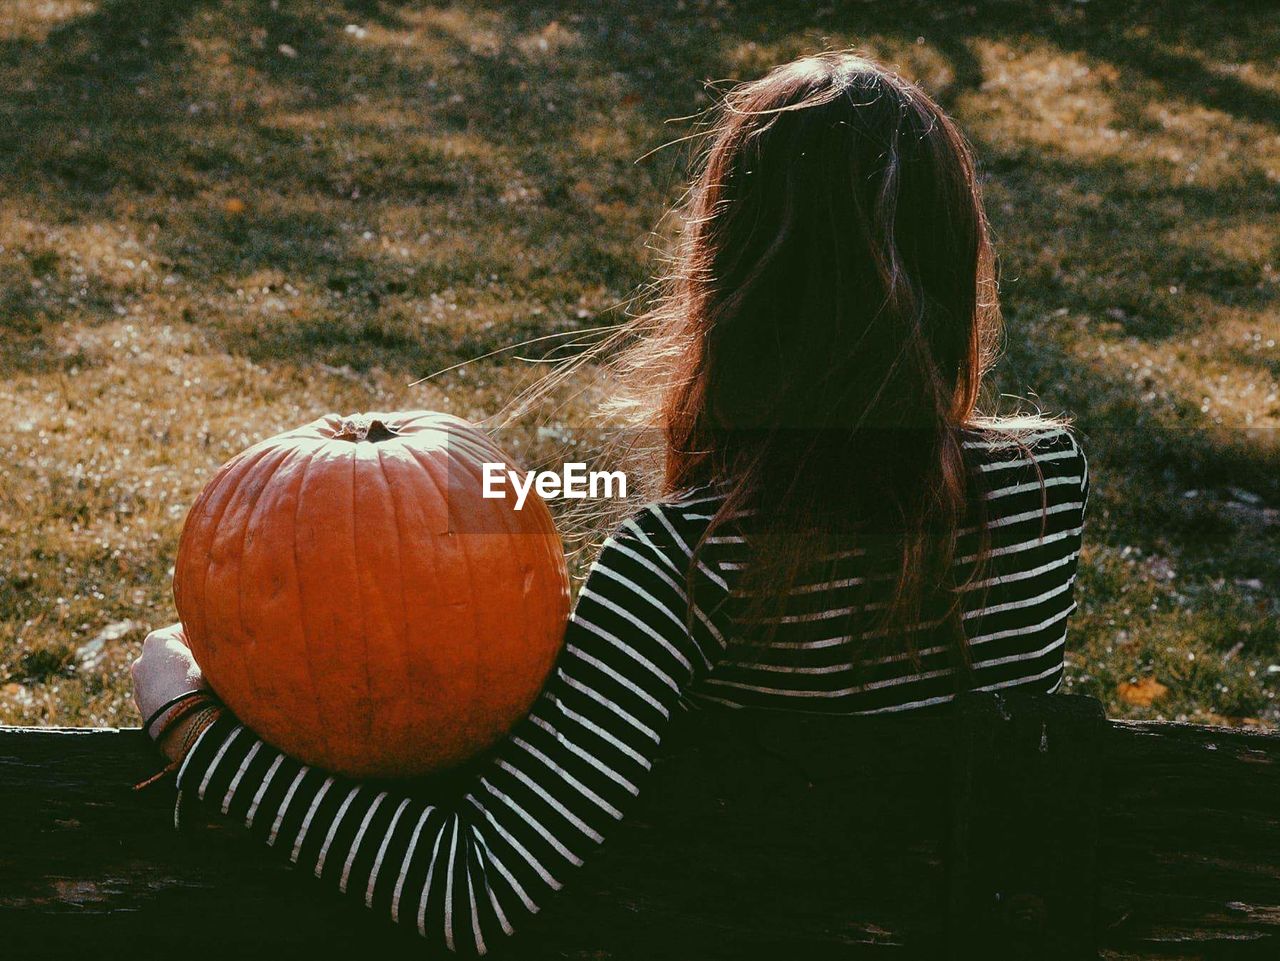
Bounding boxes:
1098 722 1280 958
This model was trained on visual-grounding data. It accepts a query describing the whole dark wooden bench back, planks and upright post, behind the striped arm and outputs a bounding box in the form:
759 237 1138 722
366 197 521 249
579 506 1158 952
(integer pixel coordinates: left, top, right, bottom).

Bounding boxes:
0 695 1280 961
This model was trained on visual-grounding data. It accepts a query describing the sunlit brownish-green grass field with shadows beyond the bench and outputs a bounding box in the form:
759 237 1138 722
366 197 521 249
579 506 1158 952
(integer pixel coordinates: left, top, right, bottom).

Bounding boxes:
0 0 1280 726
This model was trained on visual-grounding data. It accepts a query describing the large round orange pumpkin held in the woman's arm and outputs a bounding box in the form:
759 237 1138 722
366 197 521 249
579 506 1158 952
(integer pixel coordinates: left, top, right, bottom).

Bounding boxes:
173 411 568 777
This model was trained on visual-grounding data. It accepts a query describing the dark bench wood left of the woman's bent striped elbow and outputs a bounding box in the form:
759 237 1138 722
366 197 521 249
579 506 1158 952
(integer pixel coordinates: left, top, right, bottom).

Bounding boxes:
0 728 414 957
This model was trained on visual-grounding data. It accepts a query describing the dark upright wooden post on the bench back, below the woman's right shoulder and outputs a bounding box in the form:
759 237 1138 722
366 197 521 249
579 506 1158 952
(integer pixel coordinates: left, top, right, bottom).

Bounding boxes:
948 697 1106 961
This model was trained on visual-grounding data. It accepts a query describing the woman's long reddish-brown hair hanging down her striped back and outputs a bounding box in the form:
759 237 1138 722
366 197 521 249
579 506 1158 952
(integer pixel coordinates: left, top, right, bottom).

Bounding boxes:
506 52 1046 668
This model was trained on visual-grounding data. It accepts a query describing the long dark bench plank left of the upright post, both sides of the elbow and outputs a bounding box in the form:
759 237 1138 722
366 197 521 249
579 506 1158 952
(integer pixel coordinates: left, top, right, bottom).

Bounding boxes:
0 715 948 960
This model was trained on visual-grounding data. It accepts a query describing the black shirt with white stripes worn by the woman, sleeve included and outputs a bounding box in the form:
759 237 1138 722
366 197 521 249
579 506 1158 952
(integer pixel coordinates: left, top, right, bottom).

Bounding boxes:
178 429 1088 953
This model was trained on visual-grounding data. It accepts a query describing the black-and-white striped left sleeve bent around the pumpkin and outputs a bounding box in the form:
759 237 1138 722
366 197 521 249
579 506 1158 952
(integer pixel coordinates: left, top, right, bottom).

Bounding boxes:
178 507 724 955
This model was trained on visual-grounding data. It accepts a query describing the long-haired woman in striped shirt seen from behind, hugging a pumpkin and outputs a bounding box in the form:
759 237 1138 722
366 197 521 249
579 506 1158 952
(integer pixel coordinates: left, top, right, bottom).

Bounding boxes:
134 54 1088 953
